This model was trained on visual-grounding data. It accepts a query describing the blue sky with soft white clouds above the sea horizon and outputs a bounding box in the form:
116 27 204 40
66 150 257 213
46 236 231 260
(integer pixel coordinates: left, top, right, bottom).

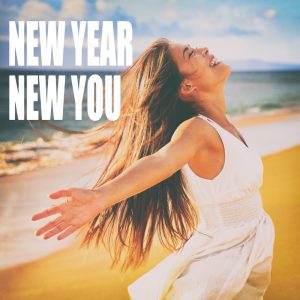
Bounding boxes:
0 0 300 67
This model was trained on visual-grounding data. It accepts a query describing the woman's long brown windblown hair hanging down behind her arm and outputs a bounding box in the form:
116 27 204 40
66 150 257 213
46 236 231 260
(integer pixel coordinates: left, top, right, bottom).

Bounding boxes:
80 39 199 270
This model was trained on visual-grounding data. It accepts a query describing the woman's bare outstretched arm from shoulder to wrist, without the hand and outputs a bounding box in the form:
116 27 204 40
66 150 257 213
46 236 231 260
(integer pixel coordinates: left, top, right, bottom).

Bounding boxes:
92 118 209 207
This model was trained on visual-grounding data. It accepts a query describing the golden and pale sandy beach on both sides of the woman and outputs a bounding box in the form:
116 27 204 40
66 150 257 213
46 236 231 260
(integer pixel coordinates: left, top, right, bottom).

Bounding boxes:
0 108 300 300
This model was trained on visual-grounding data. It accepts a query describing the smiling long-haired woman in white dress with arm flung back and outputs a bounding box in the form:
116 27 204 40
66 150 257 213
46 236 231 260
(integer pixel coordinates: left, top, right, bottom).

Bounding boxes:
32 39 274 300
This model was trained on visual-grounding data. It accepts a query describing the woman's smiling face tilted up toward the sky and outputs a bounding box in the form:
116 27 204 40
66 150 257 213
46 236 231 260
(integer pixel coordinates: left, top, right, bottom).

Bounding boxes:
169 43 231 92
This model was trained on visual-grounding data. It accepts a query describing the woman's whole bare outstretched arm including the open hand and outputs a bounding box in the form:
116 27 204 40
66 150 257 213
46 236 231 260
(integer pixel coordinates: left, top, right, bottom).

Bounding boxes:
32 117 208 239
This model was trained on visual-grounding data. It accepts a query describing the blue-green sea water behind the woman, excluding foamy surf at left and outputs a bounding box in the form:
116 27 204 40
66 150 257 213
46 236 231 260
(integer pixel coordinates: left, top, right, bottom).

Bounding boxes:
0 70 300 144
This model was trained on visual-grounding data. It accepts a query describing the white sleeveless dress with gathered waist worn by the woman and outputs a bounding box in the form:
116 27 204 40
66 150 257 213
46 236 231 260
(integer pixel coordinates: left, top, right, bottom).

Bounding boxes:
128 114 275 300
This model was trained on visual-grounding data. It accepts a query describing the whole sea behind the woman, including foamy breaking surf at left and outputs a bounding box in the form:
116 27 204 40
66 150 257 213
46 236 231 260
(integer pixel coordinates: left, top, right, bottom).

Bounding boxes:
0 70 300 176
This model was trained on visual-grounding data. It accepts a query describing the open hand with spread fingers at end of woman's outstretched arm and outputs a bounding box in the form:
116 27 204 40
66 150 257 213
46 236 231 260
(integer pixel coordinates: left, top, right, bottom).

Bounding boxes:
32 188 105 240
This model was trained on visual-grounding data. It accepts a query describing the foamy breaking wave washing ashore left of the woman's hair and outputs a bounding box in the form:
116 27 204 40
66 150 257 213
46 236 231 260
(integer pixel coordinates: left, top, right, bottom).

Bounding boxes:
0 128 109 176
